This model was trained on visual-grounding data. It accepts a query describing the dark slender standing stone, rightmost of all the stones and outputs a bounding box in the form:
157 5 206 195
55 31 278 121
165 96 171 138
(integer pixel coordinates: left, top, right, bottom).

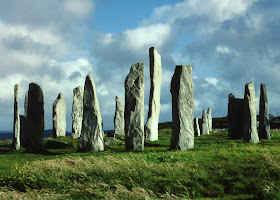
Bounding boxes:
259 83 270 140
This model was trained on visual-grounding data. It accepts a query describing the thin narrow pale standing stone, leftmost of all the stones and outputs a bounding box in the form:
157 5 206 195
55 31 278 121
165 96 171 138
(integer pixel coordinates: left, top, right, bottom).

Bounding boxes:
13 84 20 150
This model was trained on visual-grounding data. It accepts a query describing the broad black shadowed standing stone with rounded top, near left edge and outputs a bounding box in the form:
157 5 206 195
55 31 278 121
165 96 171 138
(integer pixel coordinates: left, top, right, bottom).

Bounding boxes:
24 83 45 153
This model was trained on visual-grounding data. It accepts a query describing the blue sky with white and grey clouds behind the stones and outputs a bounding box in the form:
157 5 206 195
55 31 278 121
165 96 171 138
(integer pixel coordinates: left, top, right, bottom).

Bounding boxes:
0 0 280 132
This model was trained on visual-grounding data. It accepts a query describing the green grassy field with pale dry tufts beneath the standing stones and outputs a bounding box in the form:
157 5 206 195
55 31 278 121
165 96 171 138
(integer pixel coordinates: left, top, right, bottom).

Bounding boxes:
0 129 280 199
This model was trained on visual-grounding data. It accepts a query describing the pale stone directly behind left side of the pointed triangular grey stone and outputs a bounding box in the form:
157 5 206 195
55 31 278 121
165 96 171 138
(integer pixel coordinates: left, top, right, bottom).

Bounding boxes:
72 86 84 138
